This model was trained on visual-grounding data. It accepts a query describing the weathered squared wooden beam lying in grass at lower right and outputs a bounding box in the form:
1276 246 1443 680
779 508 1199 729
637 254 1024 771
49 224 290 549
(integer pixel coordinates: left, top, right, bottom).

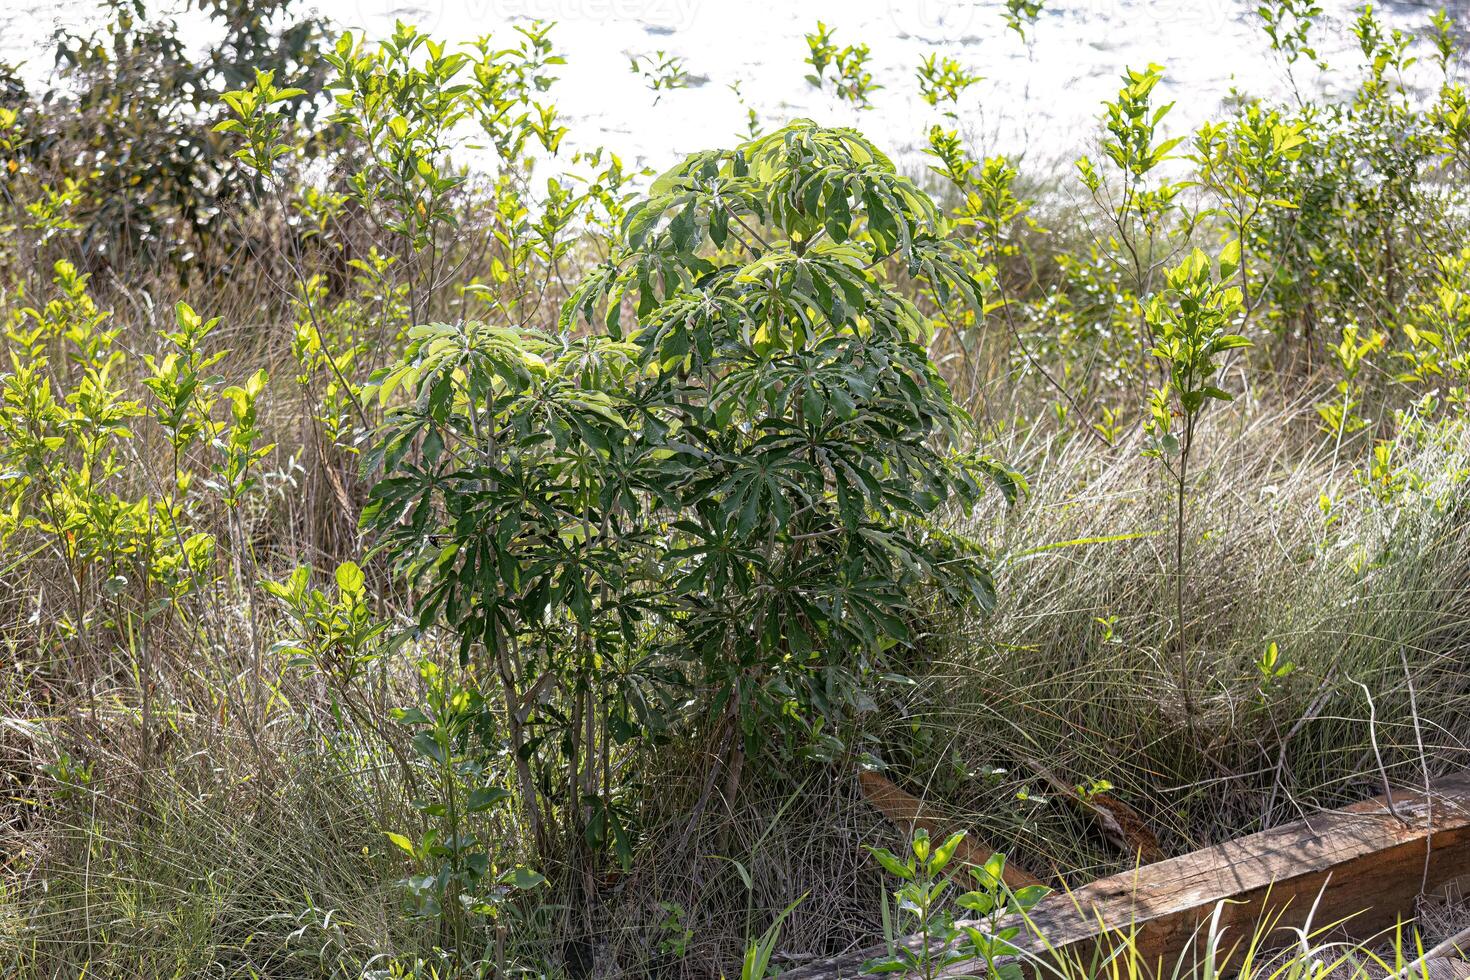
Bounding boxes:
782 774 1470 980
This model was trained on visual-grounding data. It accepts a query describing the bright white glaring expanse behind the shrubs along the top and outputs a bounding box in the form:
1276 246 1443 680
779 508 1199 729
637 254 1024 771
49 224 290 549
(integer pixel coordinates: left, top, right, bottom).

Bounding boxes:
0 0 1470 167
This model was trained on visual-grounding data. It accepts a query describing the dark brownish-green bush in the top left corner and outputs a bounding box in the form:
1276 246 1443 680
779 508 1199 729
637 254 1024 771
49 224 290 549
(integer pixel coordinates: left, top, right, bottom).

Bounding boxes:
26 0 323 263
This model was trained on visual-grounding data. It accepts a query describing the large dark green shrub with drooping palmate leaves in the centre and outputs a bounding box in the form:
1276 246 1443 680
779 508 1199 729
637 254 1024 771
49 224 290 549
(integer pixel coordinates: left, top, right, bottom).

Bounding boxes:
365 122 1019 849
